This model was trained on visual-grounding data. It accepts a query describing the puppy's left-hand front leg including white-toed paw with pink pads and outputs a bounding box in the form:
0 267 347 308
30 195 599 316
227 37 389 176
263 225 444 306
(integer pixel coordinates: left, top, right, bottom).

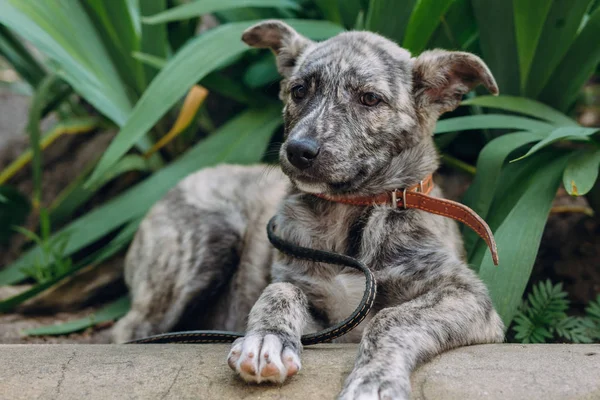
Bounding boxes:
227 283 308 383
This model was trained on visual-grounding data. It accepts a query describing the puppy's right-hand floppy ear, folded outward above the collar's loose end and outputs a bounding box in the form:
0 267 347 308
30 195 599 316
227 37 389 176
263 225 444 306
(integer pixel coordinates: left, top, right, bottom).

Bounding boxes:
413 50 498 117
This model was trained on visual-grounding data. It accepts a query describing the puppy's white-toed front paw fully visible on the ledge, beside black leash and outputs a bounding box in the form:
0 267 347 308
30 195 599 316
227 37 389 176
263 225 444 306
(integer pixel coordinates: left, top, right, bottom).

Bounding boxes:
227 333 301 383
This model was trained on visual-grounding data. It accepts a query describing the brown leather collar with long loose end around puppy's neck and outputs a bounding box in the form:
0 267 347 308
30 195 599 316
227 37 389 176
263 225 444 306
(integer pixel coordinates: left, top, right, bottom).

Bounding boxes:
315 175 498 265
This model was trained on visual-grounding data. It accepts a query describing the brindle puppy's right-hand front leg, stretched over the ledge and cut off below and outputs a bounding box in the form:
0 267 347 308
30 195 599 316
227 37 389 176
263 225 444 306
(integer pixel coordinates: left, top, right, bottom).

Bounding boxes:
340 287 503 400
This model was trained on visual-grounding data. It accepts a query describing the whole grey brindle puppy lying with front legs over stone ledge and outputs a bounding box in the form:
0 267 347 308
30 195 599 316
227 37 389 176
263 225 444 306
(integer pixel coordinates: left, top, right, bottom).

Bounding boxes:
114 21 503 399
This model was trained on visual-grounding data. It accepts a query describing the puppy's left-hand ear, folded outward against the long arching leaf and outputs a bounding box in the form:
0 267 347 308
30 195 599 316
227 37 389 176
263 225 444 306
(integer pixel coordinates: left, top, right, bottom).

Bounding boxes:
242 20 313 78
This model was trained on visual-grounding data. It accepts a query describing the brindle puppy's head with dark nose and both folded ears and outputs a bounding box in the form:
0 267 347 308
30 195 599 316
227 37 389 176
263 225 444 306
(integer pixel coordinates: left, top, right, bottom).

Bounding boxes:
242 21 498 194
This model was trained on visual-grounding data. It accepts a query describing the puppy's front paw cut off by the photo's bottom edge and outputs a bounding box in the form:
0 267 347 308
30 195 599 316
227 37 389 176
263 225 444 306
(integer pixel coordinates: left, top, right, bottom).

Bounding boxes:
338 372 410 400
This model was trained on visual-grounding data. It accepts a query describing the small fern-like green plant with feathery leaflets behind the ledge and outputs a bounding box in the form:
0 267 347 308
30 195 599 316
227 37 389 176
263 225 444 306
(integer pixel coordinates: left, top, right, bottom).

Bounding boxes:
513 280 600 343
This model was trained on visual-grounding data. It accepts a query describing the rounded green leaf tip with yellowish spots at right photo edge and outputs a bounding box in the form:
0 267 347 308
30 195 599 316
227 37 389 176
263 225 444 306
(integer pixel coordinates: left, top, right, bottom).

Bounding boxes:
563 147 600 196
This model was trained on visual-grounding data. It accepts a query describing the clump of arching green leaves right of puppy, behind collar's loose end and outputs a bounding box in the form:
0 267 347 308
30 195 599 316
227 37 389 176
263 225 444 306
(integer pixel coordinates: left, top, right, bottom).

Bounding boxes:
436 96 600 325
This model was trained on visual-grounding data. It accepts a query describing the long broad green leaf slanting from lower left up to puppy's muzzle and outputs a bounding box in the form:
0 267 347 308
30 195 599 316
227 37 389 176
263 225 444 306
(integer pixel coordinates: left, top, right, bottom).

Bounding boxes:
0 107 281 286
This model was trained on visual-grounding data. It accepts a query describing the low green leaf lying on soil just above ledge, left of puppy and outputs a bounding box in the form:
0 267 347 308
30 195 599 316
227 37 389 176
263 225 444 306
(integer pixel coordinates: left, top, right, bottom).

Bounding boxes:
24 296 131 336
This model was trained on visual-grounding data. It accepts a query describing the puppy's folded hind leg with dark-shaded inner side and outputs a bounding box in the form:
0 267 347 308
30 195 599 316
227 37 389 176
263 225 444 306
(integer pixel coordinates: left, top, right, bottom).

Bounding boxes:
113 204 244 343
